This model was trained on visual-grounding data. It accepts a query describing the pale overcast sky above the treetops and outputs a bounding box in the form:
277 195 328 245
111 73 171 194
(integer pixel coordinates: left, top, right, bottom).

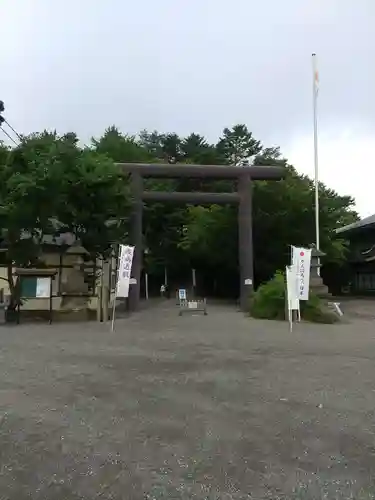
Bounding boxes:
0 0 375 216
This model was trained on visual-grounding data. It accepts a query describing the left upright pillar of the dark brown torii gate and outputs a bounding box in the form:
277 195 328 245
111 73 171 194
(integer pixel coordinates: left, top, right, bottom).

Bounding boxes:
129 172 143 311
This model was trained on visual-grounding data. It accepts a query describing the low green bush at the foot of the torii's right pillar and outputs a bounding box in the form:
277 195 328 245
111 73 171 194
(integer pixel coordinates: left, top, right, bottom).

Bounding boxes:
250 271 339 324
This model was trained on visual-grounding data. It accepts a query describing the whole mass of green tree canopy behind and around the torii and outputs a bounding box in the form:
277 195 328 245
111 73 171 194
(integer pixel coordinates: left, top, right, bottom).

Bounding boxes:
0 124 358 304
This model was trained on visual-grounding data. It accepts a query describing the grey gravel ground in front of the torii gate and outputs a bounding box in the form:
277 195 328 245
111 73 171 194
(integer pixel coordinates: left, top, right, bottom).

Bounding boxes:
0 298 375 500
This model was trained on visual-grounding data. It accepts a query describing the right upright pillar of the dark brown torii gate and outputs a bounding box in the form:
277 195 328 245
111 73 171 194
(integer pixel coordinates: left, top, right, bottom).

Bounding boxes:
238 173 254 311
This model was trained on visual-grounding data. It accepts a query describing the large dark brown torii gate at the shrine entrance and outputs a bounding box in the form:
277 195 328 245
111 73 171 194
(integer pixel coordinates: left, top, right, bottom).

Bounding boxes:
118 163 285 311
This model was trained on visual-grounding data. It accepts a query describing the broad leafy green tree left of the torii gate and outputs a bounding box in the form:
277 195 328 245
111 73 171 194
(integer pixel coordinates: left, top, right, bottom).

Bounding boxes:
0 132 128 307
